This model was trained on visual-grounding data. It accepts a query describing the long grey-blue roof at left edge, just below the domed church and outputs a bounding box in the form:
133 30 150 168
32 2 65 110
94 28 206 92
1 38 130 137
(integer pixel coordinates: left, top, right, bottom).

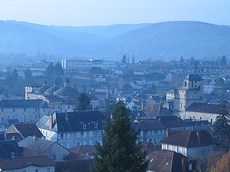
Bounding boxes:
0 99 48 108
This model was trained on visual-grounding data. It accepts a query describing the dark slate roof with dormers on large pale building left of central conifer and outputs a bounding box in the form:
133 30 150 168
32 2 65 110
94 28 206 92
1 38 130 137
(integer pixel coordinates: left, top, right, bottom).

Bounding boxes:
37 111 105 132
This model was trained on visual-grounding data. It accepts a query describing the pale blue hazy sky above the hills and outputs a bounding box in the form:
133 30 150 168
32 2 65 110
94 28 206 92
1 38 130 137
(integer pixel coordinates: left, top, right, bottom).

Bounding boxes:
0 0 230 26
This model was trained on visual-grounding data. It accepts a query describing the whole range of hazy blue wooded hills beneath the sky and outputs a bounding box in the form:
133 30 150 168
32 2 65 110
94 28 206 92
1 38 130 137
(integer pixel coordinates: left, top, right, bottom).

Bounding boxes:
0 21 230 60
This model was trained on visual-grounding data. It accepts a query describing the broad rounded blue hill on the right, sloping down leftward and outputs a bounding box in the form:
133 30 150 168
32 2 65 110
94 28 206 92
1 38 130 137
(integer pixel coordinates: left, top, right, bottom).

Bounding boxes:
101 22 230 59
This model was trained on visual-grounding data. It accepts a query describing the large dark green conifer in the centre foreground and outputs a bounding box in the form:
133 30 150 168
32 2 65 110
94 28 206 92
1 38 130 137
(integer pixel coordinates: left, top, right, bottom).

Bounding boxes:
92 102 148 172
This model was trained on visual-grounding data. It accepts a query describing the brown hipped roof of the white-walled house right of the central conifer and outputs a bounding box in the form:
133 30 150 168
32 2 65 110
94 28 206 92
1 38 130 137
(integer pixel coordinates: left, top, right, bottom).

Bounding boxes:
162 130 213 148
